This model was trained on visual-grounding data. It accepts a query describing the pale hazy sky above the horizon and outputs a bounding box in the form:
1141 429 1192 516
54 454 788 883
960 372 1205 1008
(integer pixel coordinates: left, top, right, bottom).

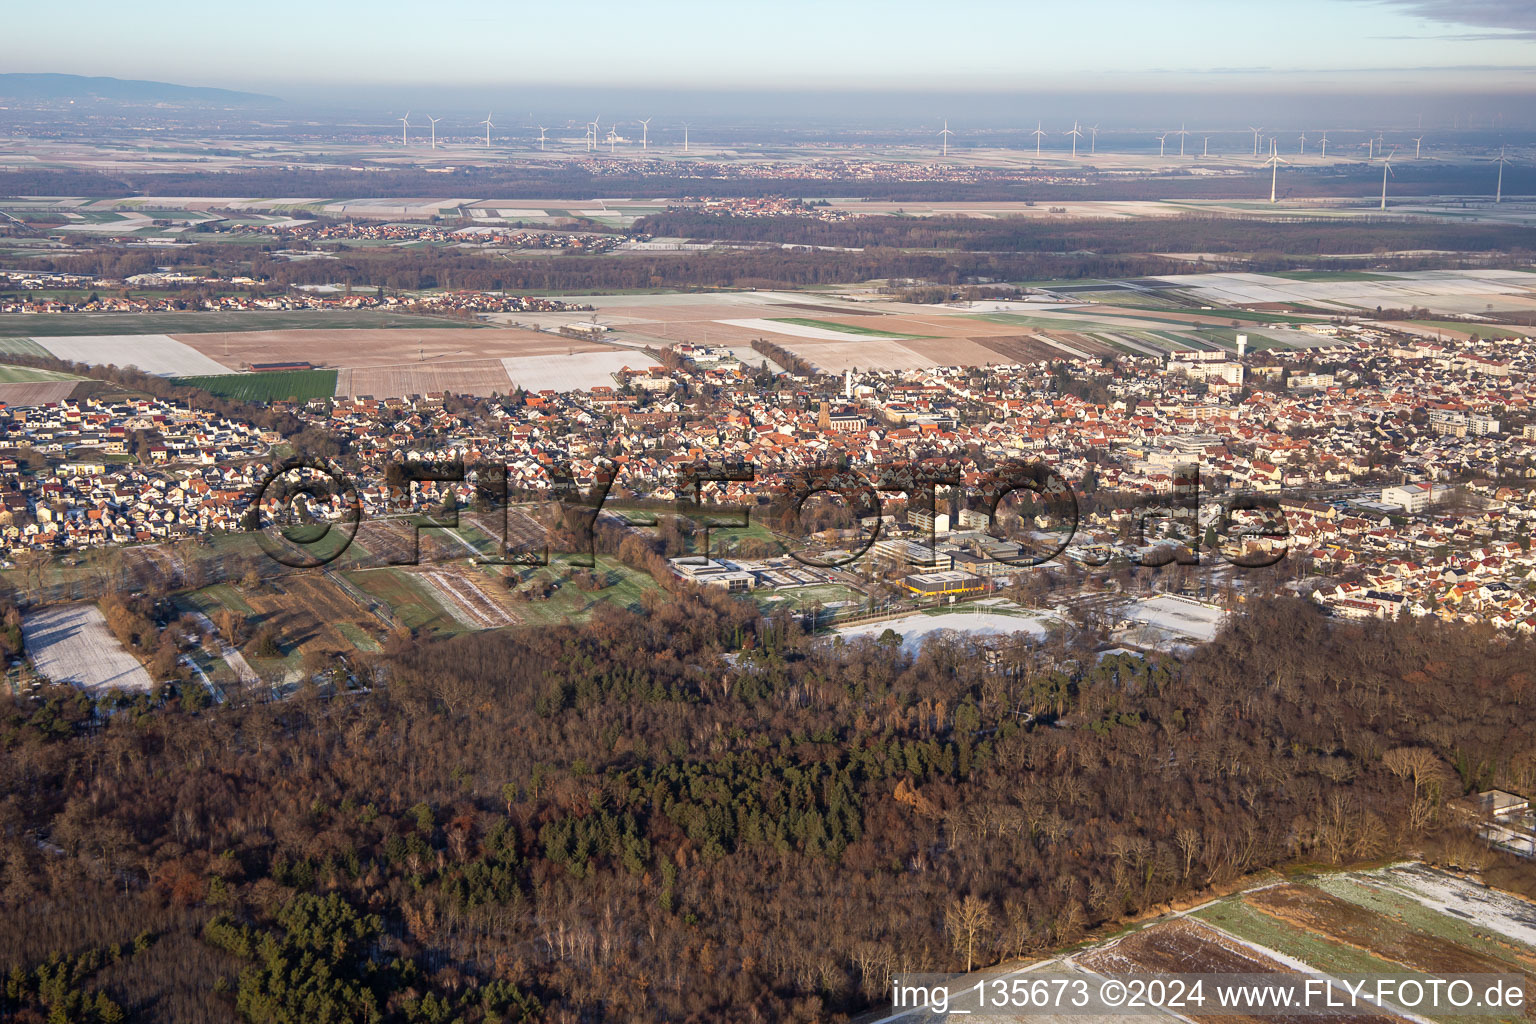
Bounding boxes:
0 0 1536 114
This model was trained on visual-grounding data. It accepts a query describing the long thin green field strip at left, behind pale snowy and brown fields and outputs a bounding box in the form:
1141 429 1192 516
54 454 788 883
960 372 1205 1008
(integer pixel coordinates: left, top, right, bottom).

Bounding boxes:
0 310 482 337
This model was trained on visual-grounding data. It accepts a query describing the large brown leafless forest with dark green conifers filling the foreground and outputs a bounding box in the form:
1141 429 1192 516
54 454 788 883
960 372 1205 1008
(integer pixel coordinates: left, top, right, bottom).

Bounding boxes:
0 586 1536 1024
